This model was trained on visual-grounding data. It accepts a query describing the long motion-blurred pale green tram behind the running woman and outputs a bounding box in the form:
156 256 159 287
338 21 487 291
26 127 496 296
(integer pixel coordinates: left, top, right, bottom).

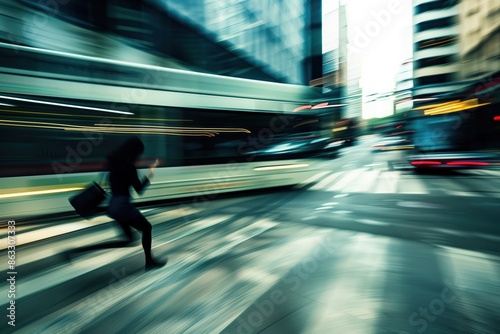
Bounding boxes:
0 43 329 219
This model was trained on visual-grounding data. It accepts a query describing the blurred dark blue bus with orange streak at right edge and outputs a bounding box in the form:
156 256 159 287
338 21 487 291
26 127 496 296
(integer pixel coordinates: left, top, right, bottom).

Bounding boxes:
407 78 500 169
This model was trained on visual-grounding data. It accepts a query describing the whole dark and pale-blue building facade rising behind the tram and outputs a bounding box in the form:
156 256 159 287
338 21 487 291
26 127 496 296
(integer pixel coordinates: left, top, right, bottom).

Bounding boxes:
16 0 322 84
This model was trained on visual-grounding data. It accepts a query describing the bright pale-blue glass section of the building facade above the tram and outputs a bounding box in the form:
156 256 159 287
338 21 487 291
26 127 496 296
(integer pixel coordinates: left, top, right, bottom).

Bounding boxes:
162 0 308 83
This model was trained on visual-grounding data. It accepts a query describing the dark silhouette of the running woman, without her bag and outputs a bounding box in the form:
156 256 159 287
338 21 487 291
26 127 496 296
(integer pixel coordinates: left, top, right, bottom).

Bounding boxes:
107 137 166 270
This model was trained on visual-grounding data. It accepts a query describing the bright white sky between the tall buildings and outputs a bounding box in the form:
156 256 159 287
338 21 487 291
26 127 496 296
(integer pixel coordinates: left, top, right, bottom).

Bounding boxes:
342 0 412 117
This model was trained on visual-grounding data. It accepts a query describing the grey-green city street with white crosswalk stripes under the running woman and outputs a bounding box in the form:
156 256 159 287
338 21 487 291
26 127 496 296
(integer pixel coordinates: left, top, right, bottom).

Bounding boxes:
1 136 500 334
